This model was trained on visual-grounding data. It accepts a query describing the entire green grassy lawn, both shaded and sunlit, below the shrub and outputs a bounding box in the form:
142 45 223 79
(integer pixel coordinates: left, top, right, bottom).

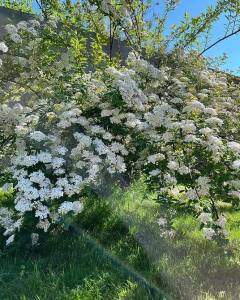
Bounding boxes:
0 182 240 300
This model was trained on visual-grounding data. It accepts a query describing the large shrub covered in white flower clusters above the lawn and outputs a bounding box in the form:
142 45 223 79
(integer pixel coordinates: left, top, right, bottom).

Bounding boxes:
0 19 240 244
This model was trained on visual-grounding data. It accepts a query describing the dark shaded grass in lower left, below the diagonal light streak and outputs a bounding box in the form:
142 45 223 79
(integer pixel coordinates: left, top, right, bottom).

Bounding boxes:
0 234 163 300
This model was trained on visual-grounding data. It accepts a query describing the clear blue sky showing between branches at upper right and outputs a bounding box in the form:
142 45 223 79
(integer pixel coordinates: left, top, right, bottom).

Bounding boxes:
34 0 240 74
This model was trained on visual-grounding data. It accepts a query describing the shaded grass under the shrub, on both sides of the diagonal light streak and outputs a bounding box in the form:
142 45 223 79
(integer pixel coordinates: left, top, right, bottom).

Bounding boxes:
0 199 170 300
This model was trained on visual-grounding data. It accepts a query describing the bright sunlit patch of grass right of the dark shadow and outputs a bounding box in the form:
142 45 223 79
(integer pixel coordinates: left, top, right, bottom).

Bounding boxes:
103 182 240 300
